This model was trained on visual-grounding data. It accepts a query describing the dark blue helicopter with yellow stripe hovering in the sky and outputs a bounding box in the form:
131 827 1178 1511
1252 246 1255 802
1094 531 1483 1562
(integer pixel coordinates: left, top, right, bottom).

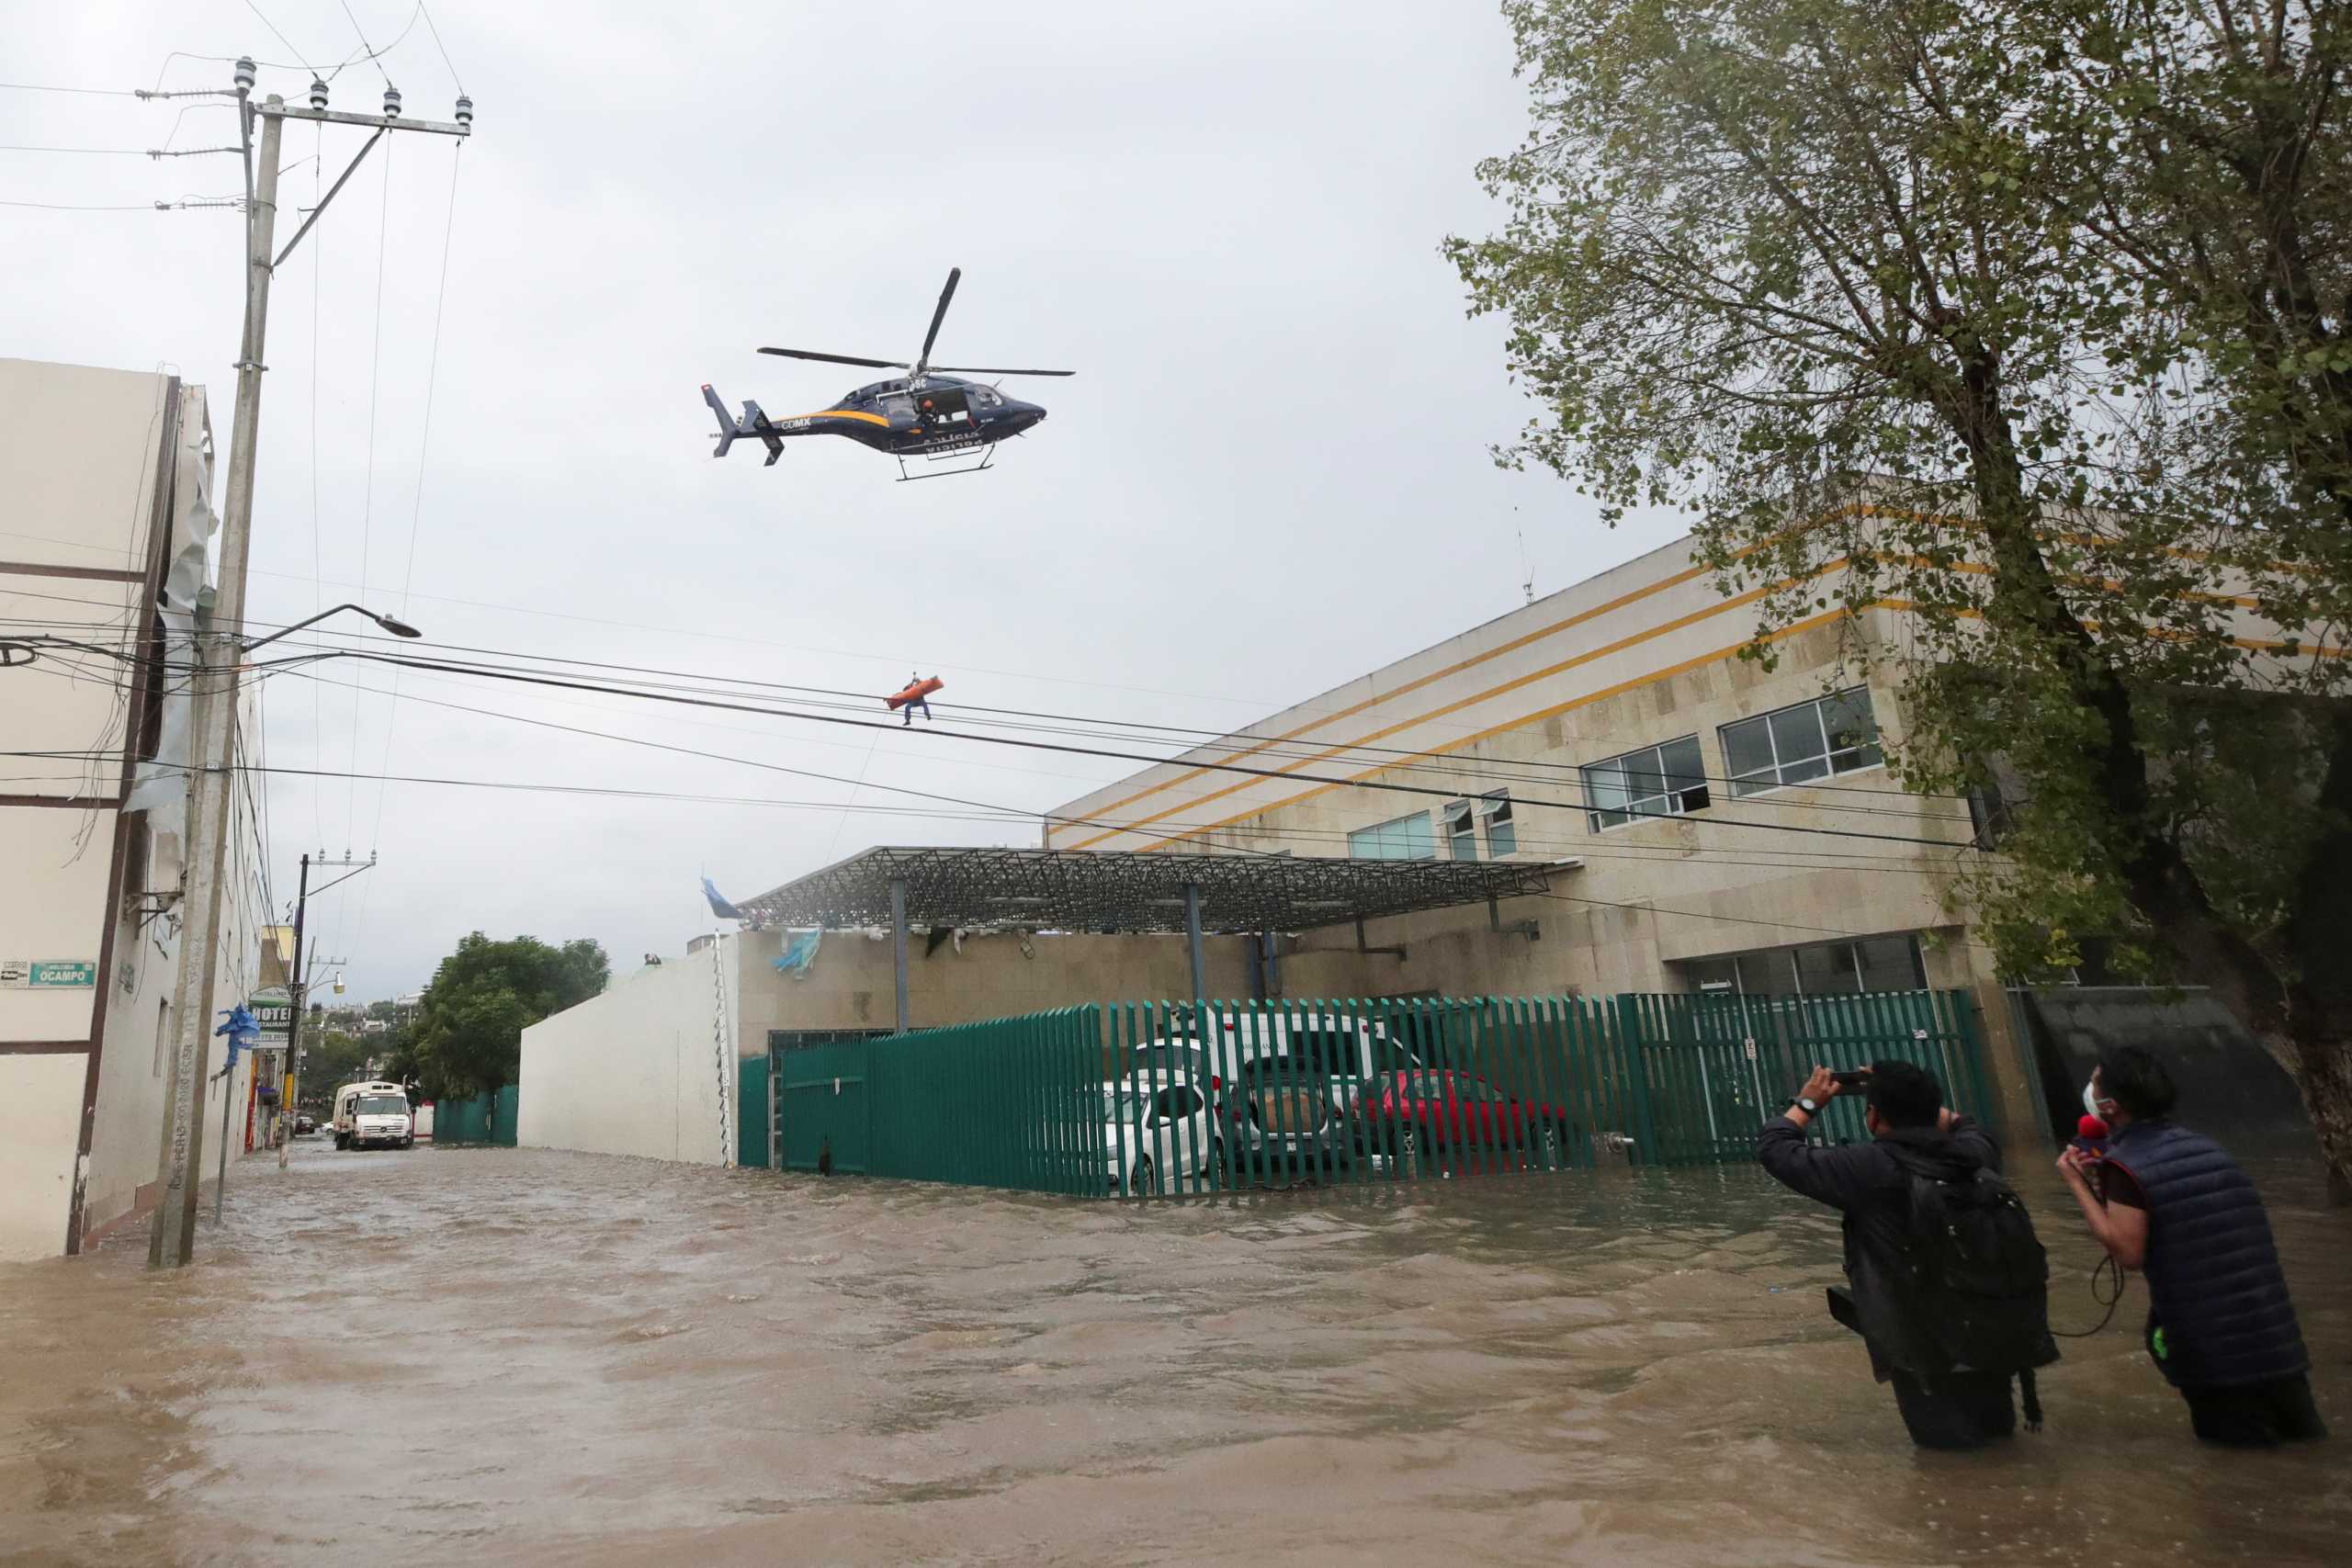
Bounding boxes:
703 268 1077 479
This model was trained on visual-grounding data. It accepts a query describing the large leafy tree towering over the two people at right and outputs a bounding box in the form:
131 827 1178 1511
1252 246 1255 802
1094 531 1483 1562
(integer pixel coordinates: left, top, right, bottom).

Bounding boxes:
1446 0 2352 1180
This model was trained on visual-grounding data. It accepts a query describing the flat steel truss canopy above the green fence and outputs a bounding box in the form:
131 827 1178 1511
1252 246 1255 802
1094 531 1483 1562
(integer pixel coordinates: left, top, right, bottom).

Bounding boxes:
736 849 1578 936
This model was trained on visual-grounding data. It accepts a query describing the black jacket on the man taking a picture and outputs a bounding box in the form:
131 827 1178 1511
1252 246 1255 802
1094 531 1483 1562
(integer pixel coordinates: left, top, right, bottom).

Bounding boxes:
1757 1117 2002 1382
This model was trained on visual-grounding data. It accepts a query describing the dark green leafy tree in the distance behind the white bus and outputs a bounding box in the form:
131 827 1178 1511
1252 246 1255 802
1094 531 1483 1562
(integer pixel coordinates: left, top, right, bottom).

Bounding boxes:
414 931 612 1098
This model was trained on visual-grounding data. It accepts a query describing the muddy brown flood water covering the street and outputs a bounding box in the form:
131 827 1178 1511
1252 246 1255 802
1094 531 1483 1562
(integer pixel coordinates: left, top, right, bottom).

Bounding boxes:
0 1143 2352 1568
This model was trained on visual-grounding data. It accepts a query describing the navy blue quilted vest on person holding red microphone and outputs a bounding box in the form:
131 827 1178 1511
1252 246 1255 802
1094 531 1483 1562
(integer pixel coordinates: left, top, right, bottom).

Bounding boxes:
2108 1122 2312 1389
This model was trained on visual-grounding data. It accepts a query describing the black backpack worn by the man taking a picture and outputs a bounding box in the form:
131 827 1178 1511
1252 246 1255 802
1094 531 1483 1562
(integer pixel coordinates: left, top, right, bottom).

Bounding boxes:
1894 1149 2058 1373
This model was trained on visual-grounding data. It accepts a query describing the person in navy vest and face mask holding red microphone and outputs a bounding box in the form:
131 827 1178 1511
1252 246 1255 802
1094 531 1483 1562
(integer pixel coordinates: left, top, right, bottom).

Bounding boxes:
2058 1046 2328 1448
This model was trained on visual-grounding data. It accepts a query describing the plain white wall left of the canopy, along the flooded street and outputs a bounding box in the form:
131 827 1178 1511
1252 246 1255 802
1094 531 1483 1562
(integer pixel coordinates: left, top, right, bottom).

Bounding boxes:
515 938 736 1166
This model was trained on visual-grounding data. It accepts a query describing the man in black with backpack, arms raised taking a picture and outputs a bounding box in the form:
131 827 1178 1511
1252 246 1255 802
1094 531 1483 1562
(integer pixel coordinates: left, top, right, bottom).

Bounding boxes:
1757 1060 2058 1448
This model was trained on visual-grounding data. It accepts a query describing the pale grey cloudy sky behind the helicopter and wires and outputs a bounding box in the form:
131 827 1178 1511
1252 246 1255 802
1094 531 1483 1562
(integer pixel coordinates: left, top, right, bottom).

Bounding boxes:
0 0 1675 997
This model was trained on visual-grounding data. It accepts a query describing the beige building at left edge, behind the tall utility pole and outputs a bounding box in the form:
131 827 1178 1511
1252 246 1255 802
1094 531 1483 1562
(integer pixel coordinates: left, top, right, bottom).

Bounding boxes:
0 360 268 1258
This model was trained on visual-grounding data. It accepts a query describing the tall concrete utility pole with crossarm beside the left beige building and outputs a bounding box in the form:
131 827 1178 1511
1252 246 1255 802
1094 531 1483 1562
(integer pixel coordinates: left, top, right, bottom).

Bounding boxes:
148 59 473 1267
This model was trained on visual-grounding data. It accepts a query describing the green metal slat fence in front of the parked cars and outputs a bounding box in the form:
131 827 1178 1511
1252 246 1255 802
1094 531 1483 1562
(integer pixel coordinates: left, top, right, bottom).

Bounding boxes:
762 992 1990 1197
